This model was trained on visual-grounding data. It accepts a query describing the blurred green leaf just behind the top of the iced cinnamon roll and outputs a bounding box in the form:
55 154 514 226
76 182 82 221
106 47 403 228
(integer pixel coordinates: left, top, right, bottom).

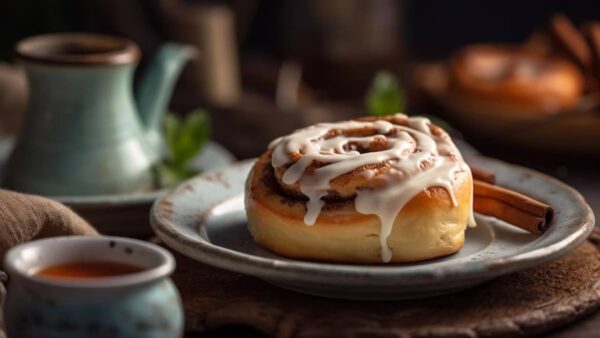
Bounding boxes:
366 71 404 116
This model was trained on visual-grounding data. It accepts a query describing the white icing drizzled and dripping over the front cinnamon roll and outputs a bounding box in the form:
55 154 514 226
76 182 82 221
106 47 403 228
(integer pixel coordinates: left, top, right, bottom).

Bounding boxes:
269 114 475 262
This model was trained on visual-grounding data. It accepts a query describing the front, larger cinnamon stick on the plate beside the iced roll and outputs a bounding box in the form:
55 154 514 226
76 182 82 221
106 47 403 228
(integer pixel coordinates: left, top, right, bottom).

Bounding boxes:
473 180 554 235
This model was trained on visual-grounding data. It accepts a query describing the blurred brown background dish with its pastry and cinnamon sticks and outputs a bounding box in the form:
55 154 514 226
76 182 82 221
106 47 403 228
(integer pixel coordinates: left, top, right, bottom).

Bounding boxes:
411 14 600 155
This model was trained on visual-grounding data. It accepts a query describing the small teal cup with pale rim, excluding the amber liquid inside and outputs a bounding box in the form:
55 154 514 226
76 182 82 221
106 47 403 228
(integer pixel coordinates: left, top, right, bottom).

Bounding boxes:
4 236 184 338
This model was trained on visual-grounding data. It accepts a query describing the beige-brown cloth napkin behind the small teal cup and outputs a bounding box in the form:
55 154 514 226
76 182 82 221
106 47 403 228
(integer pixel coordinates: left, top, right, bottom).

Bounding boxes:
0 189 98 338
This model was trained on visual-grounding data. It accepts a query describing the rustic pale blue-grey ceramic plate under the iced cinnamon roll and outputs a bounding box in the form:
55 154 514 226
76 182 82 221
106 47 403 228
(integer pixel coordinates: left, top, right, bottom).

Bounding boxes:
151 157 594 300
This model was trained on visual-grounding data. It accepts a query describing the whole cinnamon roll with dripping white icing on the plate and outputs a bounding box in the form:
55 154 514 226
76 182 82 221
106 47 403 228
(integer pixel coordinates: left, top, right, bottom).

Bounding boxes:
246 114 474 263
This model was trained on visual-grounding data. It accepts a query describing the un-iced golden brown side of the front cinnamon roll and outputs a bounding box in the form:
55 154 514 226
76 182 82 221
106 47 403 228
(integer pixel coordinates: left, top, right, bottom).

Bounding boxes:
246 150 472 263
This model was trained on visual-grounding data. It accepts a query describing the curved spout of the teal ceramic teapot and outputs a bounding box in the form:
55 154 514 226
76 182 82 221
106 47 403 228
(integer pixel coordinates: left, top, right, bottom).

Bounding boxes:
136 42 197 153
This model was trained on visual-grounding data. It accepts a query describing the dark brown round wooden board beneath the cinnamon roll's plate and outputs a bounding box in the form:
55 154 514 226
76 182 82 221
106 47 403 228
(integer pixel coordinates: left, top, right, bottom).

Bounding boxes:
173 231 600 338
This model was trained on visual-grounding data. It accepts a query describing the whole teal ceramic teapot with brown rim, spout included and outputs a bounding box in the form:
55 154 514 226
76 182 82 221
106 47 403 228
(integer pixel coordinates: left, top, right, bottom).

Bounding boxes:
3 33 194 196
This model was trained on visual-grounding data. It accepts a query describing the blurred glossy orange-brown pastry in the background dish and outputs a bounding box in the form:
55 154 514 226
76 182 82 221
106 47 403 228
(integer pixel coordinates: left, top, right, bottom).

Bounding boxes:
449 45 584 115
